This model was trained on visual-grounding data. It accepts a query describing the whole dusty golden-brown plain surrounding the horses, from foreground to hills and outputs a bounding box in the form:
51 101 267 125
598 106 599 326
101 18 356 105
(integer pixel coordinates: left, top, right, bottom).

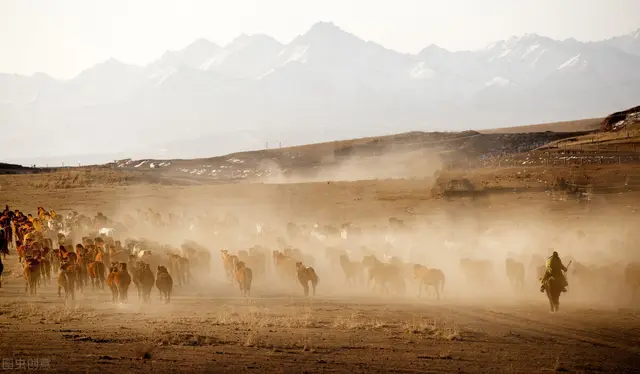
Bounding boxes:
0 141 640 373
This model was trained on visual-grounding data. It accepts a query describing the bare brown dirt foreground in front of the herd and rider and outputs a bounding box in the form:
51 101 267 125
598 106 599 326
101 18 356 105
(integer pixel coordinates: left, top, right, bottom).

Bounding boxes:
0 268 640 373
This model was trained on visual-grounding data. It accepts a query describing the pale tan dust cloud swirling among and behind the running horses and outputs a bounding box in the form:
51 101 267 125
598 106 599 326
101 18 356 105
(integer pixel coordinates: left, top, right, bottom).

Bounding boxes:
33 175 640 305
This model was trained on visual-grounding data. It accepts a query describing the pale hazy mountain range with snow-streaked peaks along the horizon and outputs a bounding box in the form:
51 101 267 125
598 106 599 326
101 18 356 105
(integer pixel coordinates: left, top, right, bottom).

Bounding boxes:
0 22 640 164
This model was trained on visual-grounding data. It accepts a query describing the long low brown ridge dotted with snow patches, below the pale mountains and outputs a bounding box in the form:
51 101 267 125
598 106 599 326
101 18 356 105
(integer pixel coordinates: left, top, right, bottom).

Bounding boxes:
106 131 584 181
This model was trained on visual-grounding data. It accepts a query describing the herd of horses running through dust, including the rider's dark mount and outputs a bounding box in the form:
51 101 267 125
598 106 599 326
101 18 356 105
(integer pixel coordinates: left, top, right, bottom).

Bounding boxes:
0 208 640 311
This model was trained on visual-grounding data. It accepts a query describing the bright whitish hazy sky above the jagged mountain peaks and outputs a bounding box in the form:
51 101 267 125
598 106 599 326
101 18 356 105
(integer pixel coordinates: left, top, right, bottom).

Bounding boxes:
0 0 640 78
